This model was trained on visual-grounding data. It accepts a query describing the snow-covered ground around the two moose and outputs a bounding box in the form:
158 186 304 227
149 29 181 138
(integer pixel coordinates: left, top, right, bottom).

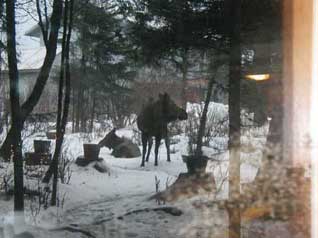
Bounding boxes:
0 104 267 237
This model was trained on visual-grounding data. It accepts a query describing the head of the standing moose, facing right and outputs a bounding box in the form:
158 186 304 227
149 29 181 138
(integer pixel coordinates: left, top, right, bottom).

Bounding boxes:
159 93 188 122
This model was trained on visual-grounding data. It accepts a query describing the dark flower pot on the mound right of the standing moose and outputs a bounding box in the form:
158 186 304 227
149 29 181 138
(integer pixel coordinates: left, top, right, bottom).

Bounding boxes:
182 155 209 174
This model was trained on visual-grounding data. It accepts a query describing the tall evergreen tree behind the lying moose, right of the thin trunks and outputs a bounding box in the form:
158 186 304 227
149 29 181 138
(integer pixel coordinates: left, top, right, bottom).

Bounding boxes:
73 1 135 131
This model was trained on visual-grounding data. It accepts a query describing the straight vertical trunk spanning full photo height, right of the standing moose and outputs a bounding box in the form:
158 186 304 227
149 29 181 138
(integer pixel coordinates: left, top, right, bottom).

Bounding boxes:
227 0 241 238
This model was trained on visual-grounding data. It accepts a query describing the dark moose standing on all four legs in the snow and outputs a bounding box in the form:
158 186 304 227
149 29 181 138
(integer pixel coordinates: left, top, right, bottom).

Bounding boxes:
137 93 188 167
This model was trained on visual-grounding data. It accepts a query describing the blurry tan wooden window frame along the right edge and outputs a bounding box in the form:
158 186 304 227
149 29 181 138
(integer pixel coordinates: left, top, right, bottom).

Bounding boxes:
282 0 314 237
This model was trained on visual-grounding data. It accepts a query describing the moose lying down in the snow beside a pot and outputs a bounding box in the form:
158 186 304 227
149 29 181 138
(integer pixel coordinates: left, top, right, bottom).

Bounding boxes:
98 128 141 158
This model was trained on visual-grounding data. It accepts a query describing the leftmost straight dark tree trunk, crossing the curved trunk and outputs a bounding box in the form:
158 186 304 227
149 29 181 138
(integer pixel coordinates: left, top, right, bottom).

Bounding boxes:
6 0 24 217
